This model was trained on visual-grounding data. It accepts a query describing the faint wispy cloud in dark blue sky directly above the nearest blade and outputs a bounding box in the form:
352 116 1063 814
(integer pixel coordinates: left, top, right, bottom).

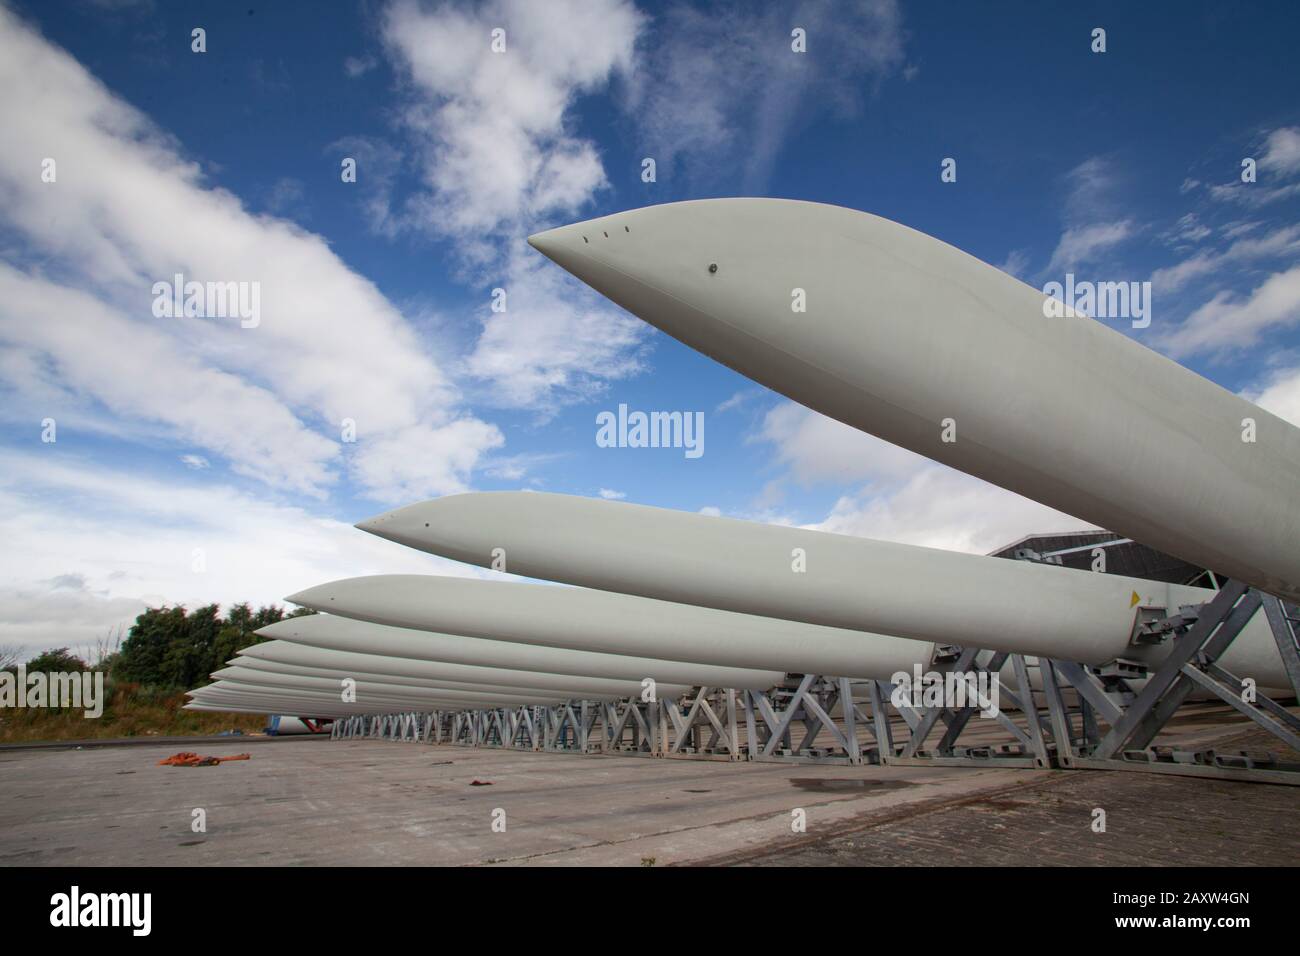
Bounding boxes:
628 0 905 191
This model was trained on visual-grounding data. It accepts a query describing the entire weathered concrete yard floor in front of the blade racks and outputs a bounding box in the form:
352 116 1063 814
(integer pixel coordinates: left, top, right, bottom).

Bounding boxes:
0 712 1300 866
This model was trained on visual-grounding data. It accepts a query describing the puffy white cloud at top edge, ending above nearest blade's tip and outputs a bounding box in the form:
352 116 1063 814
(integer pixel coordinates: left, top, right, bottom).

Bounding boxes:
382 0 641 247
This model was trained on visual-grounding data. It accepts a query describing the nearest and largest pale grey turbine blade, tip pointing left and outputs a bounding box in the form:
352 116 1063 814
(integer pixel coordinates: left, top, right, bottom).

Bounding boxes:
527 199 1300 601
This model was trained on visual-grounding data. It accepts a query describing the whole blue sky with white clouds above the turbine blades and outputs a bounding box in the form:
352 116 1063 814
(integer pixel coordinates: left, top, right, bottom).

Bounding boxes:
0 0 1300 648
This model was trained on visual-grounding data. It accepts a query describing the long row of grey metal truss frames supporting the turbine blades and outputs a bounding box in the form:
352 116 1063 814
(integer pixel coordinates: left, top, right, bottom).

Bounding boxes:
330 581 1300 786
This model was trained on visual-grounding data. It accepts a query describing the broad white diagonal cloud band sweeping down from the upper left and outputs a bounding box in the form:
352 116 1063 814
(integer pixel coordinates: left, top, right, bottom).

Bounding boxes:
0 8 499 494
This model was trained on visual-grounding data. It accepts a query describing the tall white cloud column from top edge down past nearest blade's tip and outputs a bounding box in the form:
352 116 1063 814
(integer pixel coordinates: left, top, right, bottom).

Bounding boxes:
371 0 647 411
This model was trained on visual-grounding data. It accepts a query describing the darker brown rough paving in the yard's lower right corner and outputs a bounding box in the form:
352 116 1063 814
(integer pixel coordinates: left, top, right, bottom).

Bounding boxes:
701 735 1300 866
